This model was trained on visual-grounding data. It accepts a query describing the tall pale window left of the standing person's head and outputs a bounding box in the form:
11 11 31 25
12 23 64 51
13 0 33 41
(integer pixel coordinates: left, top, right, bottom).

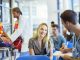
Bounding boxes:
2 0 11 34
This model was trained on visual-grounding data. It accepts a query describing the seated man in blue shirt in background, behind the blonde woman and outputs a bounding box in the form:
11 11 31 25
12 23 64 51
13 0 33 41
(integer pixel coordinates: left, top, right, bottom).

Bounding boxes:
50 24 66 51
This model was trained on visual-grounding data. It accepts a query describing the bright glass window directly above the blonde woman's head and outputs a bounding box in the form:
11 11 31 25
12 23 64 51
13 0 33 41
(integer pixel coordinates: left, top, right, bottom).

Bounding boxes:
31 4 48 30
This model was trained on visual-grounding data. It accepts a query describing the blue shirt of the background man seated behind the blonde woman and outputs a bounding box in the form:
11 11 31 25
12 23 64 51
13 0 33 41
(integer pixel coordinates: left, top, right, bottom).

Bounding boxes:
50 34 66 50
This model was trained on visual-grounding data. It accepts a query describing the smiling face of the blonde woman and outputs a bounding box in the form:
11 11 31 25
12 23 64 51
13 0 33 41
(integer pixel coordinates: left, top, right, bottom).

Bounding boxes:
38 25 48 38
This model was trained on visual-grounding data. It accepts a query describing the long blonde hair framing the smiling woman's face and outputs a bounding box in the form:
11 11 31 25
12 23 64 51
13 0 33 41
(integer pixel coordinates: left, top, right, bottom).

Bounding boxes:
33 23 49 43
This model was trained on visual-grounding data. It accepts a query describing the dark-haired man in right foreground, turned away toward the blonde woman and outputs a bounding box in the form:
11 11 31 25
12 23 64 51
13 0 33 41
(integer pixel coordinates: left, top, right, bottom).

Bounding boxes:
61 10 80 60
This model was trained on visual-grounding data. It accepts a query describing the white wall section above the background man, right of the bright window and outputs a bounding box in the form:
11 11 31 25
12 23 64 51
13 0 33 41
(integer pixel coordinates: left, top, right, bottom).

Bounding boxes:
47 0 57 23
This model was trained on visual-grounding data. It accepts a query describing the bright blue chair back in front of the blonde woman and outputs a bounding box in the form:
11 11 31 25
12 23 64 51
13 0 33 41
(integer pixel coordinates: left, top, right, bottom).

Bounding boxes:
16 55 50 60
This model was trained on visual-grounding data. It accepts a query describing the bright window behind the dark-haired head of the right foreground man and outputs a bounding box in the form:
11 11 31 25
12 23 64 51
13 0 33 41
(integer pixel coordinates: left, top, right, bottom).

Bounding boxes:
57 0 73 33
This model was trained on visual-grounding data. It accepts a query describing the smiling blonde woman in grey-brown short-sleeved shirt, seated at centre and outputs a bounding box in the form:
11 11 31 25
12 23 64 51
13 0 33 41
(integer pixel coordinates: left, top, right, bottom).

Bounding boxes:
28 23 52 59
